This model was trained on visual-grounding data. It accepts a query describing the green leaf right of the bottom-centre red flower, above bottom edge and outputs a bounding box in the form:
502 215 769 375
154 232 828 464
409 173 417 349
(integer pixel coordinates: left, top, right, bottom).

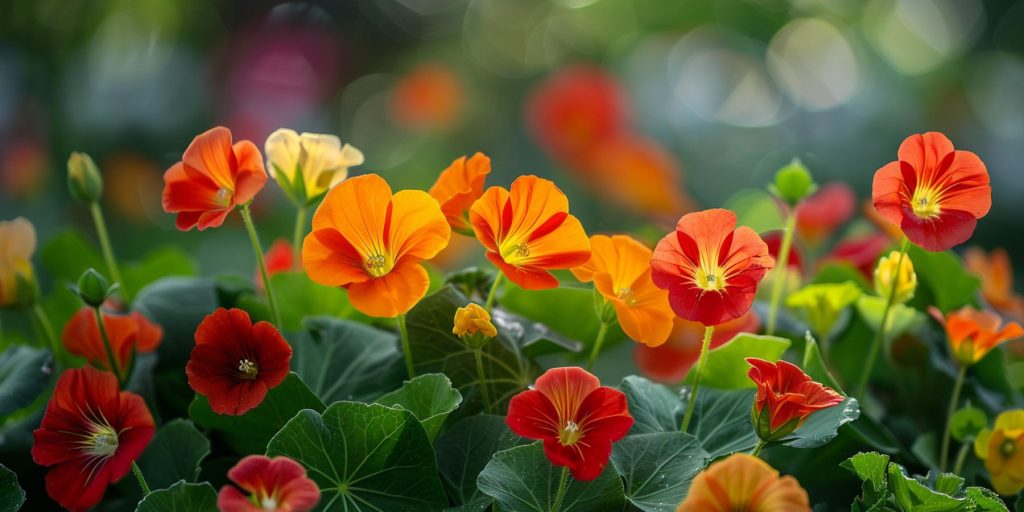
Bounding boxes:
611 432 709 512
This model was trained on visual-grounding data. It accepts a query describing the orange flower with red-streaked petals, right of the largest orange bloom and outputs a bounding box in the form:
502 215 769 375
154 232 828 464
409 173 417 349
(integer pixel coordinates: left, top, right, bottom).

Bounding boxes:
469 176 590 290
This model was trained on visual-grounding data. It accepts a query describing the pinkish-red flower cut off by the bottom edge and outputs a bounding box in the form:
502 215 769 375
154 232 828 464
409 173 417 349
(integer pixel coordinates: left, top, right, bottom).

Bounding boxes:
217 455 321 512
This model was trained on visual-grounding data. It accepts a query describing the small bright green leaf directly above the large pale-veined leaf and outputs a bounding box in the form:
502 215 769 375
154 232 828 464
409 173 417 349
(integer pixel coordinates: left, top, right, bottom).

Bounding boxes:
375 374 462 441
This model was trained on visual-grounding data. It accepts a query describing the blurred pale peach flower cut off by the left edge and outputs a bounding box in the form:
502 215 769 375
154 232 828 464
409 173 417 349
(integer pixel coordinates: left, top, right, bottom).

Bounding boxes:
0 217 37 307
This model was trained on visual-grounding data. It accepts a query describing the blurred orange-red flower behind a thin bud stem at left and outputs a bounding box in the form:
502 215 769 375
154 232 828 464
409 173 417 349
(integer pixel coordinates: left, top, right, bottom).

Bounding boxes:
60 306 164 375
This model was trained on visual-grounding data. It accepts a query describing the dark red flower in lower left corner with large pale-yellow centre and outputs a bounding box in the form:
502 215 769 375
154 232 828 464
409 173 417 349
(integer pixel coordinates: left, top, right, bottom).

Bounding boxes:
32 368 155 511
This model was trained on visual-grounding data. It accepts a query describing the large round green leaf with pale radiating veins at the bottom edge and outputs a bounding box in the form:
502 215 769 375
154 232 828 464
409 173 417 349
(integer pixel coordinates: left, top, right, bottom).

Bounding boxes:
266 401 447 511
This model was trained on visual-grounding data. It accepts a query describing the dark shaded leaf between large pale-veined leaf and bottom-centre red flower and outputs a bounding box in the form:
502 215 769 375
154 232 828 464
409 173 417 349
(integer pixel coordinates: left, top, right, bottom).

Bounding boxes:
434 415 529 510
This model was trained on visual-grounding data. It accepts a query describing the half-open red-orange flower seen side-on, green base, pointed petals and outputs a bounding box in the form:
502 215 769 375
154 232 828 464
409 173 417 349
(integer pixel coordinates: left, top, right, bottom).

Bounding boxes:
746 357 843 441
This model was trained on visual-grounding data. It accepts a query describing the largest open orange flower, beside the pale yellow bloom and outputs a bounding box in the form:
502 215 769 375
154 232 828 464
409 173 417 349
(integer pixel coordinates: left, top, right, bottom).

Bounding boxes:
302 174 452 317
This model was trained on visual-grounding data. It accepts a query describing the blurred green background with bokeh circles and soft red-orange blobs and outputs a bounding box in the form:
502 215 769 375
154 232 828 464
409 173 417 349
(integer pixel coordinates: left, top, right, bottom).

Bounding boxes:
0 0 1024 275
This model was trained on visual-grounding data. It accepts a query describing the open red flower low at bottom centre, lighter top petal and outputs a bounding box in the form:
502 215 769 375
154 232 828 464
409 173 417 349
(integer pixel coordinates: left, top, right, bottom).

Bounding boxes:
505 367 633 480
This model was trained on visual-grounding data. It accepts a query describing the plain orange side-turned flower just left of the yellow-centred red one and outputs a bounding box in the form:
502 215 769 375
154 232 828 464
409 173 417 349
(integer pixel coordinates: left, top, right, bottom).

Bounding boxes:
571 234 675 346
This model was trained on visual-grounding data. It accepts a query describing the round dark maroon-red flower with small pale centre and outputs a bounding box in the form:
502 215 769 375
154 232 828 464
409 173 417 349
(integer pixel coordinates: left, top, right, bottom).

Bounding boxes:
185 307 292 416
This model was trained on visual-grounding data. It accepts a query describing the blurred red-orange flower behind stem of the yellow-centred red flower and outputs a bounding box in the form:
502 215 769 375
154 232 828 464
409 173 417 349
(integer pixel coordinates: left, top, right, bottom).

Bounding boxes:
633 308 761 384
